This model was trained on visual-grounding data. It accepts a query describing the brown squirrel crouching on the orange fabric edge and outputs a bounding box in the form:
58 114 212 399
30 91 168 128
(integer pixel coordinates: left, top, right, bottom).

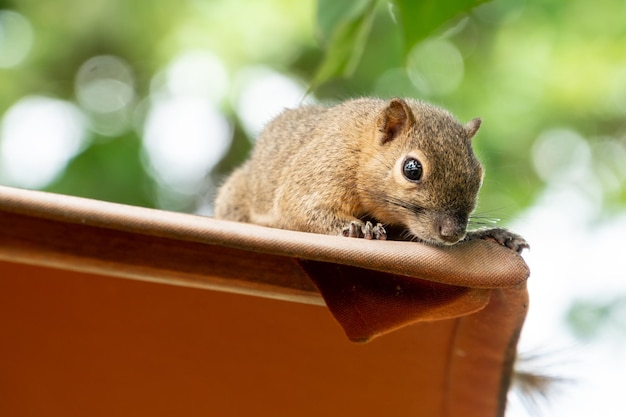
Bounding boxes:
215 98 529 252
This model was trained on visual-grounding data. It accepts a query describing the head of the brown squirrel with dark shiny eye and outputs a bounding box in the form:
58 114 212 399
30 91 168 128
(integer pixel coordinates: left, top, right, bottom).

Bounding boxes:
358 99 483 245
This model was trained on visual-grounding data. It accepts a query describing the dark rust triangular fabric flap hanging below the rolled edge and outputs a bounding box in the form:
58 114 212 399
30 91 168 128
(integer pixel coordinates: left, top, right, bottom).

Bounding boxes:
300 260 491 342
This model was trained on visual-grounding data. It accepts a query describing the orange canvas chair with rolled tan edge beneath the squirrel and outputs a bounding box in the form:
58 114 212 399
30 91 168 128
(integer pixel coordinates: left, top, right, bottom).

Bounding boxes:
0 187 529 417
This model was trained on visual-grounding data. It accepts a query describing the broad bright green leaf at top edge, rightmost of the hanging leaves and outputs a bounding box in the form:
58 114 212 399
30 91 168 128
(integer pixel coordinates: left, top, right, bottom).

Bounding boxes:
391 0 487 51
